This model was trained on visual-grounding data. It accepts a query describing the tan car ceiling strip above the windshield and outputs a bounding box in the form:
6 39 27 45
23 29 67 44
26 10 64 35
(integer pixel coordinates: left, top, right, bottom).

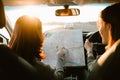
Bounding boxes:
2 0 120 6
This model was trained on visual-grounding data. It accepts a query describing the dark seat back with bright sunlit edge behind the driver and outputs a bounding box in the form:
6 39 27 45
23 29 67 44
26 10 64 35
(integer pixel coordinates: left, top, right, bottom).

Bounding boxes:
87 39 120 80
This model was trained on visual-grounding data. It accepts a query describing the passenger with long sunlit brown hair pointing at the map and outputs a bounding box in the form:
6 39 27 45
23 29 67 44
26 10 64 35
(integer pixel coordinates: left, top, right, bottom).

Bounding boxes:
9 15 64 80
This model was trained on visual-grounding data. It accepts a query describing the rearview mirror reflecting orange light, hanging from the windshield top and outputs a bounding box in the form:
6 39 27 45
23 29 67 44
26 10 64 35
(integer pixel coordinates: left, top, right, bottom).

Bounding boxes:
55 8 80 16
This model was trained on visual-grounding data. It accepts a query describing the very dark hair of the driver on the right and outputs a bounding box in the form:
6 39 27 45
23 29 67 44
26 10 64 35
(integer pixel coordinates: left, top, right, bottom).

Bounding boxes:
101 2 120 41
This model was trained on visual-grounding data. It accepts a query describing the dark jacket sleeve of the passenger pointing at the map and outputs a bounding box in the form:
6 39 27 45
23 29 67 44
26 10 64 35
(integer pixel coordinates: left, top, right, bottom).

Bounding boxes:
32 61 64 80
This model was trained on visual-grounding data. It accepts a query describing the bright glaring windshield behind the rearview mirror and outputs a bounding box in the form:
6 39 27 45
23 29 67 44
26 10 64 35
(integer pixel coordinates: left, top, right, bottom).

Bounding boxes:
5 4 109 32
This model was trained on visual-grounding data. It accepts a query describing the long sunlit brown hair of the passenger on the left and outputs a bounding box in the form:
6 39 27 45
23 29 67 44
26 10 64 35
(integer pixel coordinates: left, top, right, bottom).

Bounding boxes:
9 15 43 60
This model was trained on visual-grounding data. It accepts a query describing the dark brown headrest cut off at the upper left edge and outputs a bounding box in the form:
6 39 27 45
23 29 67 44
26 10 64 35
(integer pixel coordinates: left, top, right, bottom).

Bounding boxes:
0 0 6 29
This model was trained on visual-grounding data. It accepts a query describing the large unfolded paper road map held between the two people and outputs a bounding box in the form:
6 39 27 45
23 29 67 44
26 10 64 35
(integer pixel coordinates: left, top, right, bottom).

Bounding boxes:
43 29 85 67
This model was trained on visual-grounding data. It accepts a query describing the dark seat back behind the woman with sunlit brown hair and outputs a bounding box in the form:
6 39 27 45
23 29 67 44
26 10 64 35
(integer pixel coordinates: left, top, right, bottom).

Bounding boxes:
0 44 40 80
